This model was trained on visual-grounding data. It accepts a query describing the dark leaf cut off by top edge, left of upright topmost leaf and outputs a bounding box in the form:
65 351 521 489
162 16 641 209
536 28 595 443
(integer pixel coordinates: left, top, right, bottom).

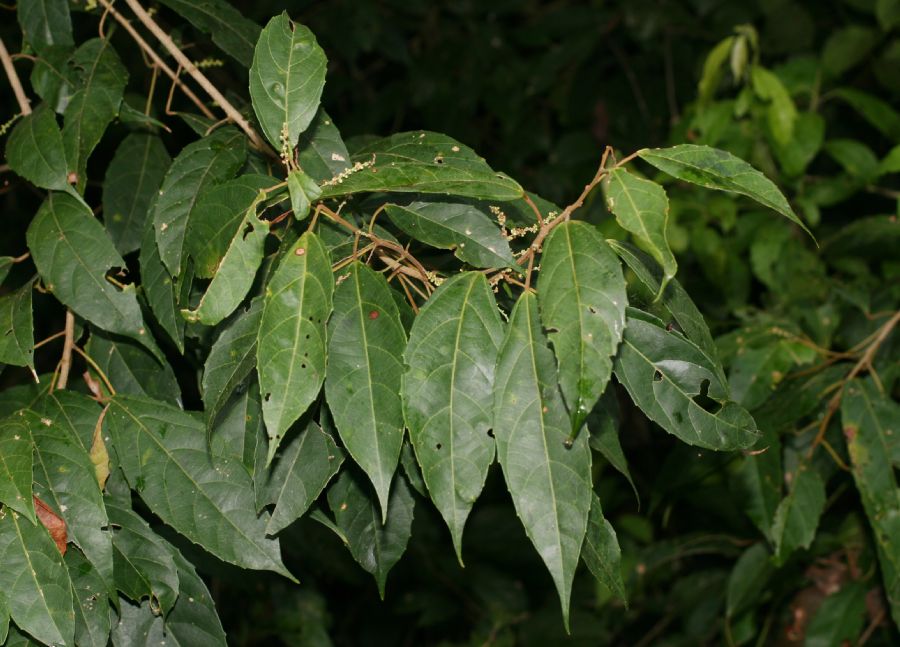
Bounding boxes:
155 0 260 67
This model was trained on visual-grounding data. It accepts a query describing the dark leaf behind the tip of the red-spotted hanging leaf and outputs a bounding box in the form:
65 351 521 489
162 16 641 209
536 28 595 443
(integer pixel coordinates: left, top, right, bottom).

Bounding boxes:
328 470 416 600
